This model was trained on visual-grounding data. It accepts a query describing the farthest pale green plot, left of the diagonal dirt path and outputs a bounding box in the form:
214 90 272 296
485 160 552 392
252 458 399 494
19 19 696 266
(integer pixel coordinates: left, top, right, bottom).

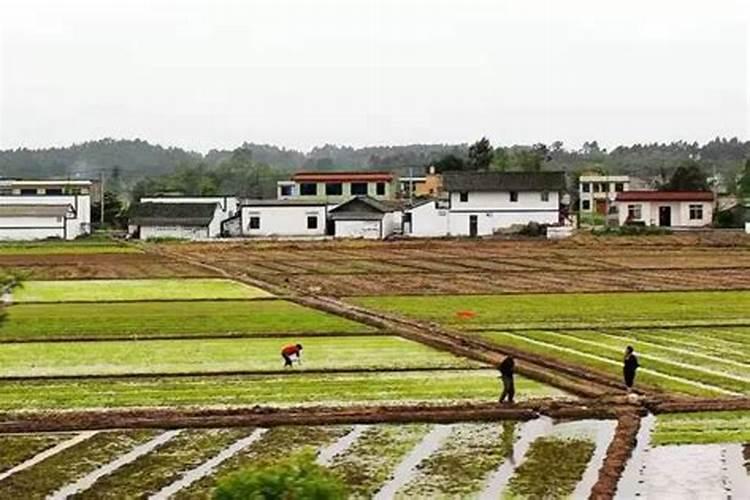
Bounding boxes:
13 278 271 303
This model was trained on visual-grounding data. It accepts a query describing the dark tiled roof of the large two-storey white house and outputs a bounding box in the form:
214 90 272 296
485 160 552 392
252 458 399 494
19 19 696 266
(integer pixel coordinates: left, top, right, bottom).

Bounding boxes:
443 172 565 192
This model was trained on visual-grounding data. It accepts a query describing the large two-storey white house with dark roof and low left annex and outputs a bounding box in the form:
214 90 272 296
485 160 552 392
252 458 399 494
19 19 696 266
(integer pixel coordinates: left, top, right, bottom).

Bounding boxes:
418 172 565 236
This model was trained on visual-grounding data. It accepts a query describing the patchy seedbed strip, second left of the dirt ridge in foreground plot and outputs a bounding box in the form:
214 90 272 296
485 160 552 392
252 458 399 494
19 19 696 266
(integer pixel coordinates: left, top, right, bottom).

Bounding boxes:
398 422 516 498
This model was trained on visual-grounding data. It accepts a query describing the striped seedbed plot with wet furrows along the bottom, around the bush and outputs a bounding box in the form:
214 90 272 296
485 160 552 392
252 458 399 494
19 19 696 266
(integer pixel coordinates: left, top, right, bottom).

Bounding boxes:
0 422 607 499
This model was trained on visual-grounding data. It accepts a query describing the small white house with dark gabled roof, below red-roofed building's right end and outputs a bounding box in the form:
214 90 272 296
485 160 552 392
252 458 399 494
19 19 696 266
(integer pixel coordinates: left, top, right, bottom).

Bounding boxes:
329 196 402 240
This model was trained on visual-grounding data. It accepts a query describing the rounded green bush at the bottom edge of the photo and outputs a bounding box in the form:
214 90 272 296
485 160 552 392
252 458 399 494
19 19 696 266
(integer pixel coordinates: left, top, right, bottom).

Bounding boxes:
214 452 348 500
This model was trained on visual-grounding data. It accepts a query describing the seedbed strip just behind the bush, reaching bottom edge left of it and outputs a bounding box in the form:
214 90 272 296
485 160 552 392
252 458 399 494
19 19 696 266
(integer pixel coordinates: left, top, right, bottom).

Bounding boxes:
173 426 349 500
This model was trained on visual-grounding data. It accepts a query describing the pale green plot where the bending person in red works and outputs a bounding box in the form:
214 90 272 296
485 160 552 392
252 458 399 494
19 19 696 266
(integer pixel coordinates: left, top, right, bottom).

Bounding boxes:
0 336 480 376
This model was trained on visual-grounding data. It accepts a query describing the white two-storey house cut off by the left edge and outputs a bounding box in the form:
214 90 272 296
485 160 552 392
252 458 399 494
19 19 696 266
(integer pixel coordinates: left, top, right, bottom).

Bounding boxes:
0 179 93 240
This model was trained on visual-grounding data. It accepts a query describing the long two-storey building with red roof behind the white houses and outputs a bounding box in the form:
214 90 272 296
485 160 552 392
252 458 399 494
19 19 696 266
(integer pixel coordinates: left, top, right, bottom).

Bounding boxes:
277 172 395 203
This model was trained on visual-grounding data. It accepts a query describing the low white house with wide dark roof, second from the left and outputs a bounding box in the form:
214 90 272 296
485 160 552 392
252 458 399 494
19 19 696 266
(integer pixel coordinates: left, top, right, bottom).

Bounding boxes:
128 202 224 240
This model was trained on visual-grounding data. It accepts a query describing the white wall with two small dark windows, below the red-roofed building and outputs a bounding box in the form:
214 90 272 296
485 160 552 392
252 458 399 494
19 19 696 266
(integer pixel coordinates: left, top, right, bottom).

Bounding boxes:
242 205 327 236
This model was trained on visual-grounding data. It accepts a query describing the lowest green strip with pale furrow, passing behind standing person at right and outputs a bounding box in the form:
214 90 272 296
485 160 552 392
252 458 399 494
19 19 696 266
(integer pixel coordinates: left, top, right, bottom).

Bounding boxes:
483 332 742 396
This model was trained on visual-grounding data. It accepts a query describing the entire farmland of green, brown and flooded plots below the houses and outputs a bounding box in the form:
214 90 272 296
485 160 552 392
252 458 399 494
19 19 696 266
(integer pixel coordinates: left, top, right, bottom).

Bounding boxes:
0 233 750 499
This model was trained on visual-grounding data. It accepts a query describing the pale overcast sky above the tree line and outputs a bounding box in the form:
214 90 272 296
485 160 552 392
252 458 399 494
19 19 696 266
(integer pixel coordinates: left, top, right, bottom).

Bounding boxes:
0 0 750 151
